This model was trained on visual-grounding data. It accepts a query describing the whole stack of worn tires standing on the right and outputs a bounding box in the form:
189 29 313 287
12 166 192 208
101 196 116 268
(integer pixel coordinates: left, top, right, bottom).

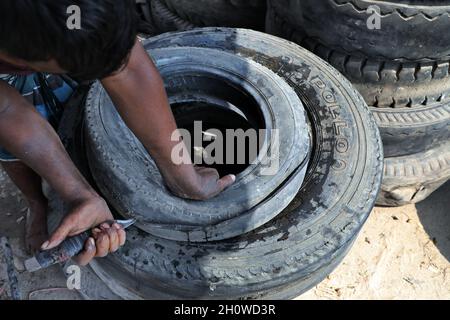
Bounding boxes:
266 0 450 206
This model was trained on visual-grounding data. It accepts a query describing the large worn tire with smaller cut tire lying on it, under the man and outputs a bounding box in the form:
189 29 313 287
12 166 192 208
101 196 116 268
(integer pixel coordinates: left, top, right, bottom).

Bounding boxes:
49 28 383 299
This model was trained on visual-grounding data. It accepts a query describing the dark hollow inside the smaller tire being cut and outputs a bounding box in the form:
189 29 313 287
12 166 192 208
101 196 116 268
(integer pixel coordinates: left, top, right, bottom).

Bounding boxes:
169 73 266 176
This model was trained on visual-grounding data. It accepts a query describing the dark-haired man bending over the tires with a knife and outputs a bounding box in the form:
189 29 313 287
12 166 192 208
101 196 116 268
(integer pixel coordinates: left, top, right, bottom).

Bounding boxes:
0 0 235 264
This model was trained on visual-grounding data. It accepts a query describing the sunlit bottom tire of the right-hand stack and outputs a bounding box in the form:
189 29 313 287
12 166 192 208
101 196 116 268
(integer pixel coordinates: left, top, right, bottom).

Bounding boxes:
377 140 450 207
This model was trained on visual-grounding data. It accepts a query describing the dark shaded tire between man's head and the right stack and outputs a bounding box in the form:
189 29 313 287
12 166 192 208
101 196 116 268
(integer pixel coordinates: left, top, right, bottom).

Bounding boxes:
137 0 266 33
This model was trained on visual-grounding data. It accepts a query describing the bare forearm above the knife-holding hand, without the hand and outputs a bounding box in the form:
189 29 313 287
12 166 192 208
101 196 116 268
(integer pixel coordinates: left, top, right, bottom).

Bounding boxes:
0 81 96 201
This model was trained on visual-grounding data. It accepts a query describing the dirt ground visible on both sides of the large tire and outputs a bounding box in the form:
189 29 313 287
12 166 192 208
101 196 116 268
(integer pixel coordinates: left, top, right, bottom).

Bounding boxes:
0 165 450 300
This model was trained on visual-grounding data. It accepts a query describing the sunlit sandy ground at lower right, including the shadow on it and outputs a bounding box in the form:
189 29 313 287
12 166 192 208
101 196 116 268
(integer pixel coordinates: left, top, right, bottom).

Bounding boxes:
299 182 450 299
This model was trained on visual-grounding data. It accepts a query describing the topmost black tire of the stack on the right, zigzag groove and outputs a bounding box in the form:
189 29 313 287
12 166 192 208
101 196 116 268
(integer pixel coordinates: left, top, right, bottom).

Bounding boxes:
269 0 450 62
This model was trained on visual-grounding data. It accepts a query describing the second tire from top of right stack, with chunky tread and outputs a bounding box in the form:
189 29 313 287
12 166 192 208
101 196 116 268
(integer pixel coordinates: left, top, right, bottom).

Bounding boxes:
266 0 450 108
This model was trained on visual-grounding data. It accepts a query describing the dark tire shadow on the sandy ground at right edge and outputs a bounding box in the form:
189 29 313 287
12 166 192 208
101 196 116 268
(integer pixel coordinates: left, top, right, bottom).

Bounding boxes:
416 181 450 262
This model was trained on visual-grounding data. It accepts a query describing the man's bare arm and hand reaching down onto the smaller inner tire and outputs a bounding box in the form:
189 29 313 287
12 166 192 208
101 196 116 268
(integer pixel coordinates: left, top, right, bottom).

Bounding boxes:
102 41 235 200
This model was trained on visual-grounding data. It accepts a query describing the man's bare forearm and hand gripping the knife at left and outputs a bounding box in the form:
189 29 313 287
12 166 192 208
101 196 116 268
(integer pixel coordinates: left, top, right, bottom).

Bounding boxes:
0 81 125 263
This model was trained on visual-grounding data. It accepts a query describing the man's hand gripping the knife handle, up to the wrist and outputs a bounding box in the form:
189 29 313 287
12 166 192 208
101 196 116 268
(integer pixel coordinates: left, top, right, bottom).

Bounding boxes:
42 197 126 265
